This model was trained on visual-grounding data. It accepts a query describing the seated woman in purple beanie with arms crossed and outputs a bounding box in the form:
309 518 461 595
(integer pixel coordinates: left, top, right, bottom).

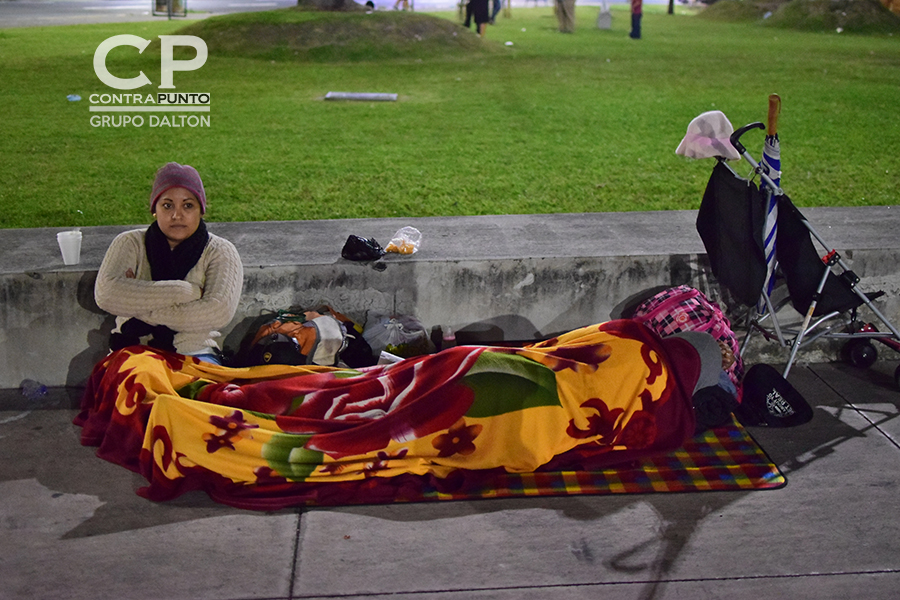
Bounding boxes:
94 162 244 364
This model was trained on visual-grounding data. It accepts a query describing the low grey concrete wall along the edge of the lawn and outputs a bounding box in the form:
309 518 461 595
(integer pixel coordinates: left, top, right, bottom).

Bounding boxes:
0 207 900 388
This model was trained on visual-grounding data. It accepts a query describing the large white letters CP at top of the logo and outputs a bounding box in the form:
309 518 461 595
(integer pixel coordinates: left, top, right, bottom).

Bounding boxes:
94 34 207 90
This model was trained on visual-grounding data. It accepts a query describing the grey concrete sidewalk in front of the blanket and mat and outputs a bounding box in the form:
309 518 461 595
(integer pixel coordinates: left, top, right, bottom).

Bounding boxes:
0 361 900 600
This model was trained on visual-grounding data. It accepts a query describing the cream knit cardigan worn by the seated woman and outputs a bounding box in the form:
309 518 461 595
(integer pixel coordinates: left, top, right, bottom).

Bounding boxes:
94 229 244 354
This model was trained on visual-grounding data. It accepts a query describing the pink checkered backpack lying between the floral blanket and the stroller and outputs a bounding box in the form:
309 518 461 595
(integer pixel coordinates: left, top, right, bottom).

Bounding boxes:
631 285 744 390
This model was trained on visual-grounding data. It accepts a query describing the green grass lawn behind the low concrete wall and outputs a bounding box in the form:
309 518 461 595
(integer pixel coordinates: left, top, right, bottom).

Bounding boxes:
0 5 900 228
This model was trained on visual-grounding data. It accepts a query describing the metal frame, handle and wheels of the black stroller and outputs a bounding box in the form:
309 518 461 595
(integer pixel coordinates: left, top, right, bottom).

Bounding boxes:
717 123 900 383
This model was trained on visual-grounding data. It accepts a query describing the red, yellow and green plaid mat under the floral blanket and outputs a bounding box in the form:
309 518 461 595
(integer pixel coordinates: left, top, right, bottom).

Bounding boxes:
419 421 787 501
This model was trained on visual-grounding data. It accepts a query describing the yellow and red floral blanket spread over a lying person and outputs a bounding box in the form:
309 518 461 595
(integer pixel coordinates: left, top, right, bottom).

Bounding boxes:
75 320 699 510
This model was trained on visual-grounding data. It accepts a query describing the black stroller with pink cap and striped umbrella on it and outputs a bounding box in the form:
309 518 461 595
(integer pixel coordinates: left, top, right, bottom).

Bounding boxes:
677 96 900 386
